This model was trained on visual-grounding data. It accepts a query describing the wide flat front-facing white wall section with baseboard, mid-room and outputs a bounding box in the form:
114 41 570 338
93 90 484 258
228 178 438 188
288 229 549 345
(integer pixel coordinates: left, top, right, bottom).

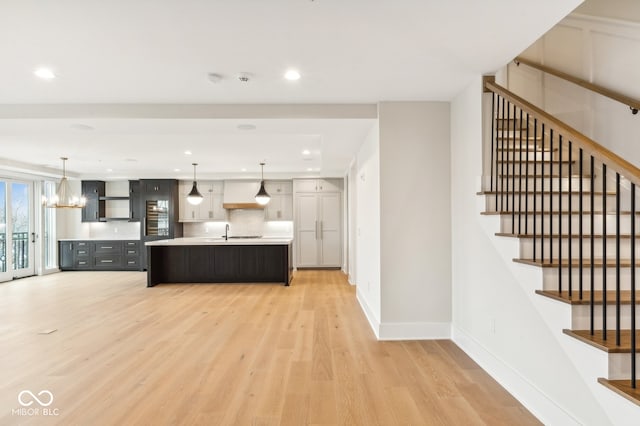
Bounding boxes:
379 102 451 339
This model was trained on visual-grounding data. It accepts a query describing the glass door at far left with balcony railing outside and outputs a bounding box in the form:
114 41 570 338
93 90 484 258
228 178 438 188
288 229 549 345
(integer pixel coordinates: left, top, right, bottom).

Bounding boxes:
0 180 35 281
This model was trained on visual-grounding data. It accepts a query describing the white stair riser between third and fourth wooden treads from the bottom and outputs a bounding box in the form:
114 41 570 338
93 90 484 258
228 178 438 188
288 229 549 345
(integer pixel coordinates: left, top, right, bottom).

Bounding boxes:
542 266 640 293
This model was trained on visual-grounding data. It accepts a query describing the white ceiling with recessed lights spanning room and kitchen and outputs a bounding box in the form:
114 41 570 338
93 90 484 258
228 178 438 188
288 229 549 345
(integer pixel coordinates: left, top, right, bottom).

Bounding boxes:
0 0 580 179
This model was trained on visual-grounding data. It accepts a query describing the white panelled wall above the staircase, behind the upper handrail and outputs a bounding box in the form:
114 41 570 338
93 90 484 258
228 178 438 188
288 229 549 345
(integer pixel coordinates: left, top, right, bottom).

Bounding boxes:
507 13 640 165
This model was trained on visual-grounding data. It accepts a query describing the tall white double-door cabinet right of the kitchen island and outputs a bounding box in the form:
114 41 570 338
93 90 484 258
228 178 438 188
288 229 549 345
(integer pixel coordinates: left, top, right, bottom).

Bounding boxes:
293 179 343 268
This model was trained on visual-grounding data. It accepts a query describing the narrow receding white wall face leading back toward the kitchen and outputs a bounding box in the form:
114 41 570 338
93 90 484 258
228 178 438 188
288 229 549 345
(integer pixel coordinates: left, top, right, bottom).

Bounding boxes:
349 125 381 330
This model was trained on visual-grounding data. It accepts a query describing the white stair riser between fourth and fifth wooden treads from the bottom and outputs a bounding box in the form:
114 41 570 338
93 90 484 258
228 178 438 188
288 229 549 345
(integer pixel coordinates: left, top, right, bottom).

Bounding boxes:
520 237 640 260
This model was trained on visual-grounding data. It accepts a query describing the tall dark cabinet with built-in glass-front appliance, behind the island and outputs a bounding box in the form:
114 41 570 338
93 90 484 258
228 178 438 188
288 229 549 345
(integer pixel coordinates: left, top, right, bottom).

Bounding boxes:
140 179 182 269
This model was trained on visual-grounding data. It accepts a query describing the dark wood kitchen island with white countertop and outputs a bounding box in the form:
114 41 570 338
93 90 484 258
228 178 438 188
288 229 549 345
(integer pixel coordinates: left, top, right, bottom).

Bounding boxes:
145 238 293 287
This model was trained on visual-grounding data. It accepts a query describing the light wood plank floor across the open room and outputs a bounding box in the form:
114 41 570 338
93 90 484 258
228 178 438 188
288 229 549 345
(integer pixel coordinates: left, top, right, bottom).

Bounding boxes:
0 271 539 426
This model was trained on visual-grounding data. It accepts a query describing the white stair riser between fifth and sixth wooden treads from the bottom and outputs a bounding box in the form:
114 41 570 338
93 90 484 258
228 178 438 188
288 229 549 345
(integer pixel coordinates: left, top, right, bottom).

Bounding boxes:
500 214 640 235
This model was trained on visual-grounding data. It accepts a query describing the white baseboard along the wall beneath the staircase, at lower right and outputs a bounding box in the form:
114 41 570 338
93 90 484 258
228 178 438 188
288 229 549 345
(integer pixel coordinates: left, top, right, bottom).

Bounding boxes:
451 325 581 426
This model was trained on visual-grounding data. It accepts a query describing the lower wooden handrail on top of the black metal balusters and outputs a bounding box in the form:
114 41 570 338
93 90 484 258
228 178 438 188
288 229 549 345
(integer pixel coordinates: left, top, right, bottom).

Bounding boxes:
484 80 640 186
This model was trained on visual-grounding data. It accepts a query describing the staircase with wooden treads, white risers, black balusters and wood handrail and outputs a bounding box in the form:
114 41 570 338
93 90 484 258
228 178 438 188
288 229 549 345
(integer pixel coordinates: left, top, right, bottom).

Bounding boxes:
480 80 640 410
